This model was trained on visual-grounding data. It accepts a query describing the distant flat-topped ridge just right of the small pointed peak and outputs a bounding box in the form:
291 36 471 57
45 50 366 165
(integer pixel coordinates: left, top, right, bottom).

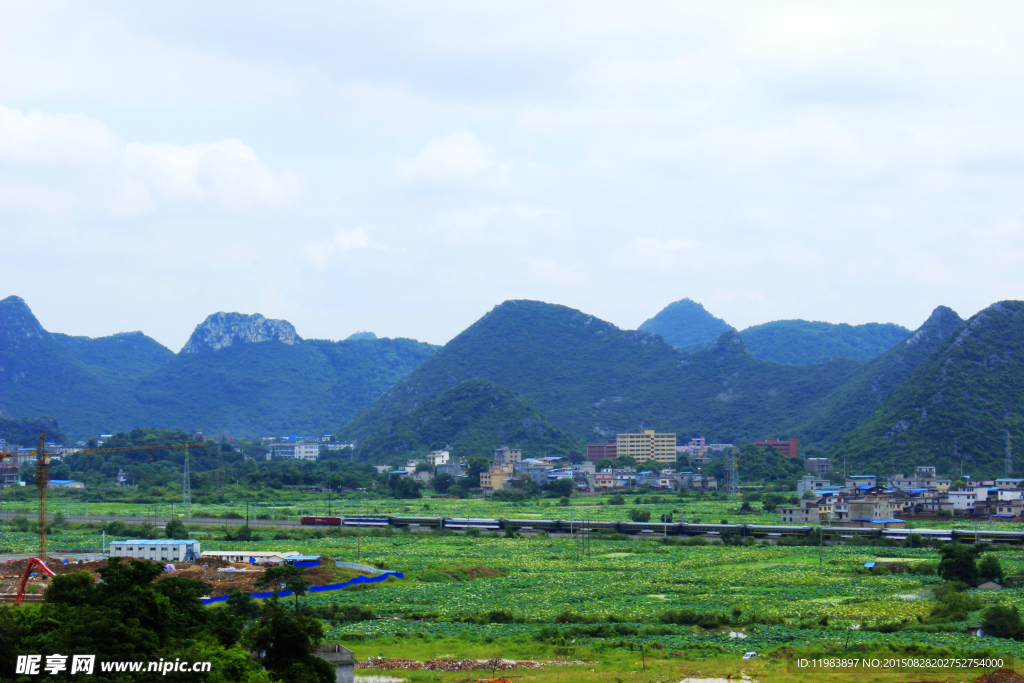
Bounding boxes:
739 321 910 366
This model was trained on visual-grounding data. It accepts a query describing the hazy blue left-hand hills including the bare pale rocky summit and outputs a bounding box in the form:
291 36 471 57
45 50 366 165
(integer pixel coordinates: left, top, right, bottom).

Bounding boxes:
0 297 436 436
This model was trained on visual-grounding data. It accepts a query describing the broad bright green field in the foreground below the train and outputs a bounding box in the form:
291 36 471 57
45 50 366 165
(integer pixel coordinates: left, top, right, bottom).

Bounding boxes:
0 520 1024 683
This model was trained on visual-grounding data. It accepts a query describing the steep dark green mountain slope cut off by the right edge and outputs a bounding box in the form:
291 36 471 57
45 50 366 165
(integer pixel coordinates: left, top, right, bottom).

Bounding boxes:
834 301 1024 476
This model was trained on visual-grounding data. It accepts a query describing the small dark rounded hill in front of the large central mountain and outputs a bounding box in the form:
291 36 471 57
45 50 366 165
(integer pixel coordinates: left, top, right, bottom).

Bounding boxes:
358 380 585 461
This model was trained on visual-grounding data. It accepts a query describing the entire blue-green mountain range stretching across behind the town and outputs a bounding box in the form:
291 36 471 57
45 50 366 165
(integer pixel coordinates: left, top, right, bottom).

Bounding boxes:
0 297 1024 473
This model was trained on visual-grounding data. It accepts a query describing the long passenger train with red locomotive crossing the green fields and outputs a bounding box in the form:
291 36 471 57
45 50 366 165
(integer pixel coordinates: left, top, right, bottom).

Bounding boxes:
301 516 1024 544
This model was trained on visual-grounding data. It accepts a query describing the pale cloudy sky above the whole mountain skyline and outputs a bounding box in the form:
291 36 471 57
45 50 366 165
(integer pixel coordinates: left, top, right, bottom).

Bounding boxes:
0 0 1024 351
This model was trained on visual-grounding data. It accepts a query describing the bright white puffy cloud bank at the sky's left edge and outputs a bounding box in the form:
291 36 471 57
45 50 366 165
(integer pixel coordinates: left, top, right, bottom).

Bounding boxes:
0 106 302 217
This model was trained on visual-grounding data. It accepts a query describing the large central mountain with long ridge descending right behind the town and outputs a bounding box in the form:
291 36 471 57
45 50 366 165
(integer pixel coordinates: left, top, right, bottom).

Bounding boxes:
340 301 955 444
